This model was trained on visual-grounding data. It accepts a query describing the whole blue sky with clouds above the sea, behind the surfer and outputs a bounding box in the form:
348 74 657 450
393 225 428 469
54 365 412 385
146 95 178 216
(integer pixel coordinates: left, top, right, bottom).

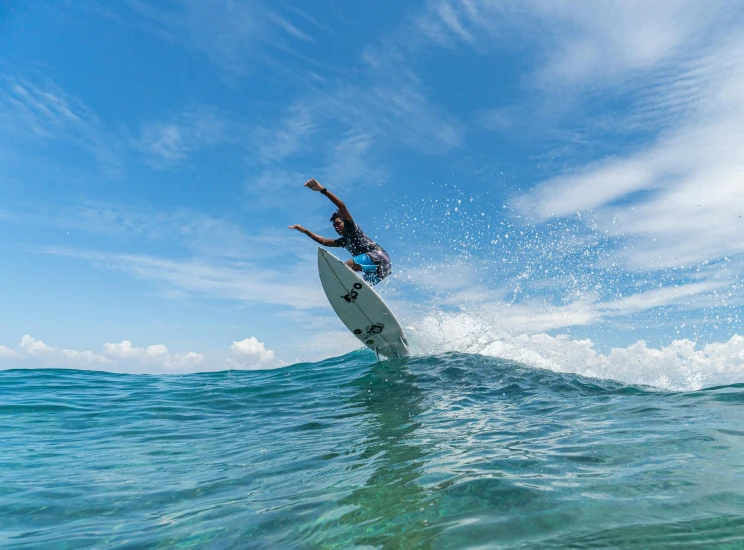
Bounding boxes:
0 0 744 380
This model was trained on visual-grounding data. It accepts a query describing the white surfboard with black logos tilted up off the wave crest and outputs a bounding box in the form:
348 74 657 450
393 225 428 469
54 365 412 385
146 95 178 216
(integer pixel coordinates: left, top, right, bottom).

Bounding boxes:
318 248 409 358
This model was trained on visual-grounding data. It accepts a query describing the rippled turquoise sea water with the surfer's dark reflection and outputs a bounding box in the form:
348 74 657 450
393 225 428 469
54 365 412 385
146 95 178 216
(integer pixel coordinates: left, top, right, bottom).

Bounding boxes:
0 351 744 548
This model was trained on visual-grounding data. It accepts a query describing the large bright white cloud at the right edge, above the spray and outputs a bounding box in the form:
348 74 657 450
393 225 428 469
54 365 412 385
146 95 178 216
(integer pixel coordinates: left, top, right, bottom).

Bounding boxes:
516 34 744 269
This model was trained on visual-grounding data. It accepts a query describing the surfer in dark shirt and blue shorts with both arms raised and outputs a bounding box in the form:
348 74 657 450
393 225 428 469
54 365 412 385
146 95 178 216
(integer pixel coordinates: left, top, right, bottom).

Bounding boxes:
289 178 392 285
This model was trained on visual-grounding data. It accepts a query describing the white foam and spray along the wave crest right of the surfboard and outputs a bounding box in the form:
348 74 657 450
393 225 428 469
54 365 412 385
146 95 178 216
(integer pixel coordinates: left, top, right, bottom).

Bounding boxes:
406 312 744 391
